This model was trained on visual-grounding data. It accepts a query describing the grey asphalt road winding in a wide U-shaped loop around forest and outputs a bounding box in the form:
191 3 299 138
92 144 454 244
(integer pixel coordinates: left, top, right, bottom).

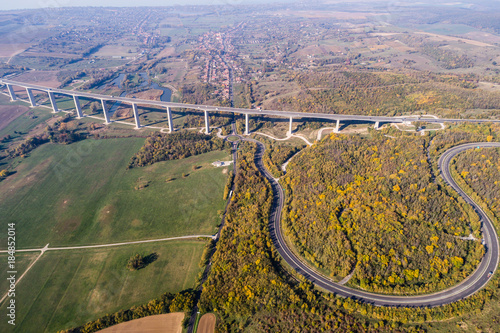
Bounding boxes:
252 139 500 307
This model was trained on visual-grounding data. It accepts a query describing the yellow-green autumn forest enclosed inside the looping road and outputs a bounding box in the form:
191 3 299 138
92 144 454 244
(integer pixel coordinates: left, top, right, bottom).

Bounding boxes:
283 134 484 294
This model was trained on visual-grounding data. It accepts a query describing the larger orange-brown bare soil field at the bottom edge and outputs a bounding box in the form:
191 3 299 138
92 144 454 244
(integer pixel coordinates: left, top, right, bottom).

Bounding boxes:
98 312 185 333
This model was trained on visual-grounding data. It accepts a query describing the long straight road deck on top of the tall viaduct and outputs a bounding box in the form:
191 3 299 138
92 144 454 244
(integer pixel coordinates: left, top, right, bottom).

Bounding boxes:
0 79 500 123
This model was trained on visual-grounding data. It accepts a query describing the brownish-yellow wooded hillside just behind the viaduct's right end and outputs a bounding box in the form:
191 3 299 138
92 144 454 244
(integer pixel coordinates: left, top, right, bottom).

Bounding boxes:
269 70 500 118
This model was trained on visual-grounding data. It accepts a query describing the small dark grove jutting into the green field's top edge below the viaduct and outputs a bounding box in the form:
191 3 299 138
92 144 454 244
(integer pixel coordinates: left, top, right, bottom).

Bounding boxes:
129 131 231 168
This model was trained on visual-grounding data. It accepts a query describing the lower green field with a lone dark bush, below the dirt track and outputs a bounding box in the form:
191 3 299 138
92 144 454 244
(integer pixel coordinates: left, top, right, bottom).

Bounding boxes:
0 240 206 332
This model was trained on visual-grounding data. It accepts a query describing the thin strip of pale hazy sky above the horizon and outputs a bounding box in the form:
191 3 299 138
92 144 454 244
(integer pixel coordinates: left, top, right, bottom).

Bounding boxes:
0 0 296 10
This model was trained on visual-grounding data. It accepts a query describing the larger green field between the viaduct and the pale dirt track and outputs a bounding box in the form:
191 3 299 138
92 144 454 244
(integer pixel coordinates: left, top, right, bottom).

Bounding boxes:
0 138 229 249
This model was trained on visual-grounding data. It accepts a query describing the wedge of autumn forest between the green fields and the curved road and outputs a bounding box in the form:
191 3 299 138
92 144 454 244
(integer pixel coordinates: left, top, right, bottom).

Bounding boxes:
200 142 423 332
